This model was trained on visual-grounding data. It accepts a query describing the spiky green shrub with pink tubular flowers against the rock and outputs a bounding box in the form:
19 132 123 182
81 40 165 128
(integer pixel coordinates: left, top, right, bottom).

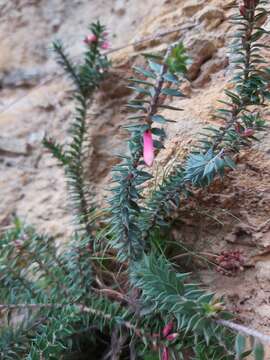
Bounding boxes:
0 0 269 360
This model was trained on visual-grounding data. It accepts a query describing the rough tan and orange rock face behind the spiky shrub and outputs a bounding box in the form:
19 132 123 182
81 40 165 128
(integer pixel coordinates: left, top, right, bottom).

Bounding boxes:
0 0 270 348
